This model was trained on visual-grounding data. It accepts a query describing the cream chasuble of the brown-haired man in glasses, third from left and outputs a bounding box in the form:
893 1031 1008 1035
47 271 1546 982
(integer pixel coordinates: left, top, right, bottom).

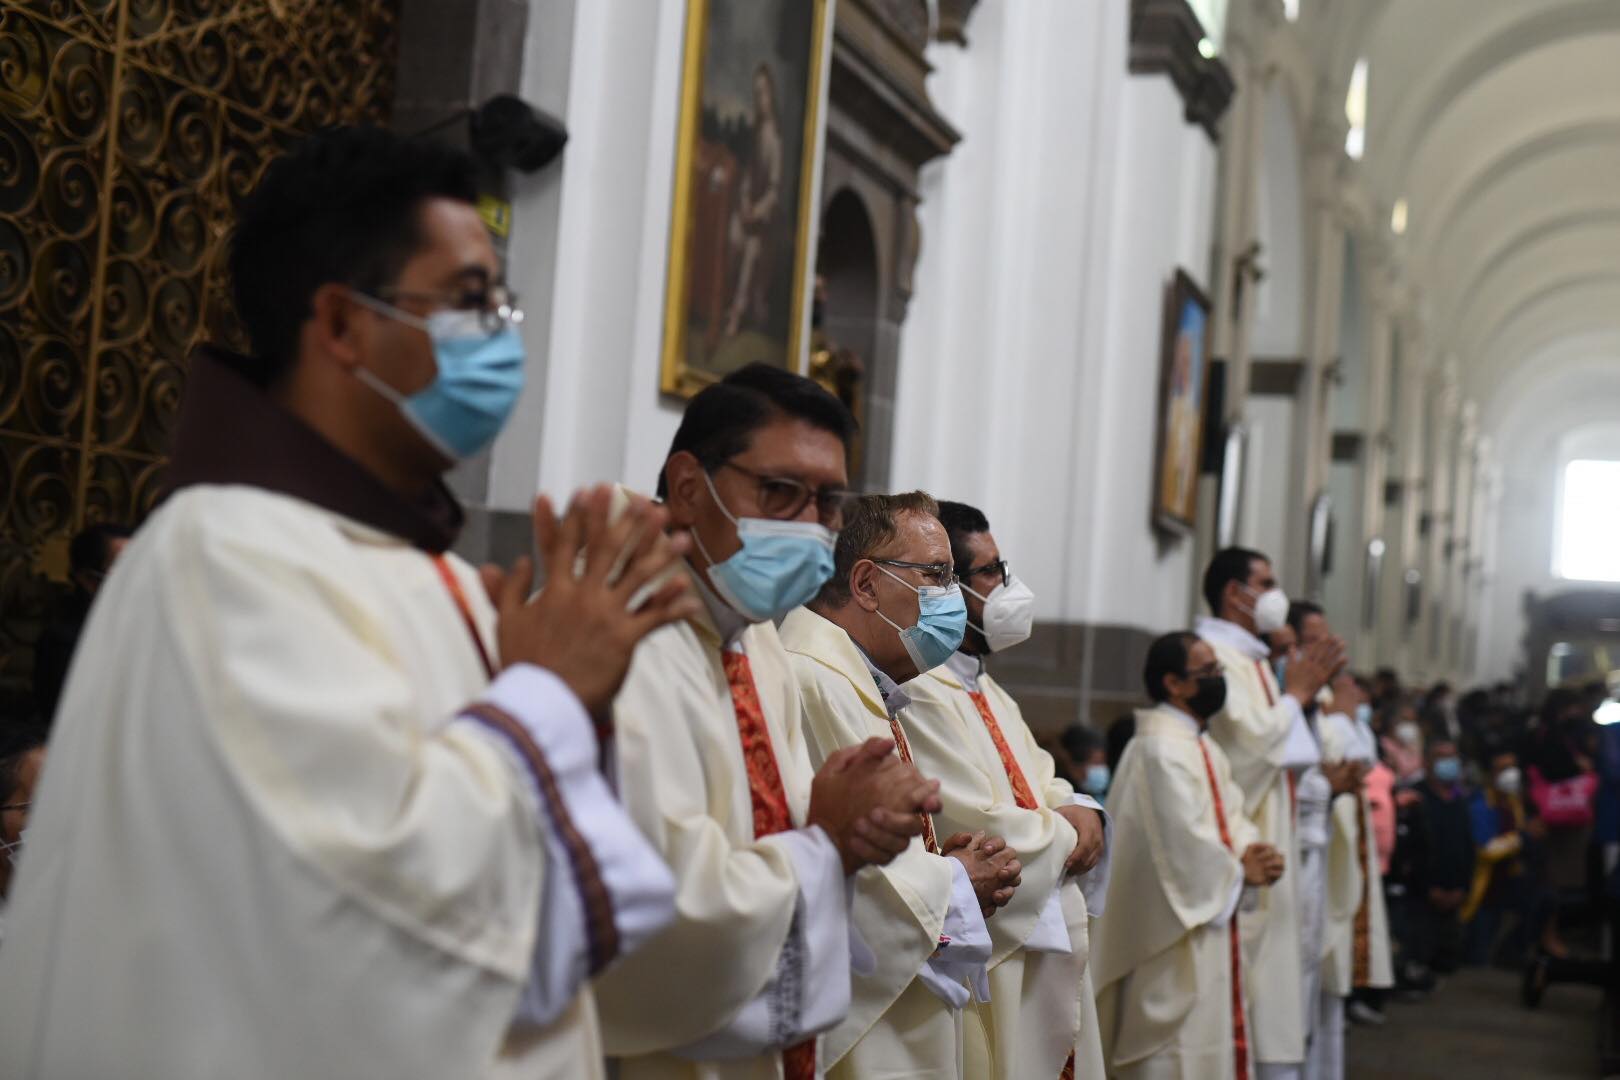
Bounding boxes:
782 607 995 1080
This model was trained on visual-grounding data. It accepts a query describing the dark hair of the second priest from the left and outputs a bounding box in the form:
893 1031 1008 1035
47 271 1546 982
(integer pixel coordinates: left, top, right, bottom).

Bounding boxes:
658 363 855 499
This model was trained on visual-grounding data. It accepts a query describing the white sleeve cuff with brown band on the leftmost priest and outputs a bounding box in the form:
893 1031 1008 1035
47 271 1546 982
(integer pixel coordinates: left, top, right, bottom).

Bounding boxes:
462 664 676 1025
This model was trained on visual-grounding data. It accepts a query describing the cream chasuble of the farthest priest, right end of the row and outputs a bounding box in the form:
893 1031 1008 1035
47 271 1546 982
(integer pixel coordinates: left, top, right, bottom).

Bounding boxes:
1320 712 1395 997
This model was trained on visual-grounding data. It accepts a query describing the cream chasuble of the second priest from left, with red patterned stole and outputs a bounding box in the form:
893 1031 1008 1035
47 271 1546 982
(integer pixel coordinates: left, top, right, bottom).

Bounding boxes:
596 576 851 1080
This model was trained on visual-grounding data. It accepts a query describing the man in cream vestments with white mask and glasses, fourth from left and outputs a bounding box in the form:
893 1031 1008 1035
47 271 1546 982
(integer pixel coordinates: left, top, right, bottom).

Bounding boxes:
904 502 1111 1080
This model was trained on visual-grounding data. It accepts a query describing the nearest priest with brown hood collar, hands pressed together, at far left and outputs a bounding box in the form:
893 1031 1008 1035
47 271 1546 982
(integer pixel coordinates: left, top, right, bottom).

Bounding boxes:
0 130 690 1080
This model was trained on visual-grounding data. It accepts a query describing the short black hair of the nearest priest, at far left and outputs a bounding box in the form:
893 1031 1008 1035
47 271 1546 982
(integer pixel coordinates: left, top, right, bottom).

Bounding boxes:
230 126 478 384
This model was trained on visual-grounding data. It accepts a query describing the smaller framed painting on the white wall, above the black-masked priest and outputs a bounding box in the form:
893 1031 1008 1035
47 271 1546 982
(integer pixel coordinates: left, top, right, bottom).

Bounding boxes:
1153 270 1210 533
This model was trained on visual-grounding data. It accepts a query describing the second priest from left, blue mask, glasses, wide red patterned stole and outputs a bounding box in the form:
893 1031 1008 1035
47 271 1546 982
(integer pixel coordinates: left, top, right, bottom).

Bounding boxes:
596 364 938 1080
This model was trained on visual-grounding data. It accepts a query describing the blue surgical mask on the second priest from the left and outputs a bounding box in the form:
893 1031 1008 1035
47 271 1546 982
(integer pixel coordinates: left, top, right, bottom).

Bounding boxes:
692 473 838 622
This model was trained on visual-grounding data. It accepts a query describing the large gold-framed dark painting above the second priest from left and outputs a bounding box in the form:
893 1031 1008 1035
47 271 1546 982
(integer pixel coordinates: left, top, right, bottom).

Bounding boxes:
659 0 829 397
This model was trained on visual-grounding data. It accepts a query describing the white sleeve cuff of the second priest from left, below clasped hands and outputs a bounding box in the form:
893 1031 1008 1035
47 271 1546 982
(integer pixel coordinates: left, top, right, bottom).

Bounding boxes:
674 827 851 1061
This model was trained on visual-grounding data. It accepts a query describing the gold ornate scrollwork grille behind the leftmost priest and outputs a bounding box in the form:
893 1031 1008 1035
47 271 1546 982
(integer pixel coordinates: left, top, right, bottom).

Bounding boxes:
0 0 397 702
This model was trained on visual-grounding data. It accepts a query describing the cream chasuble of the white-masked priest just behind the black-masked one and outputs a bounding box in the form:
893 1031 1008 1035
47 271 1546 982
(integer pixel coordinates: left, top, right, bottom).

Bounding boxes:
1196 619 1319 1064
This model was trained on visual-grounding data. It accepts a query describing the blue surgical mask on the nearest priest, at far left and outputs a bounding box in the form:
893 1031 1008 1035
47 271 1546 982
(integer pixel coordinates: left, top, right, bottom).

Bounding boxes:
353 293 523 461
